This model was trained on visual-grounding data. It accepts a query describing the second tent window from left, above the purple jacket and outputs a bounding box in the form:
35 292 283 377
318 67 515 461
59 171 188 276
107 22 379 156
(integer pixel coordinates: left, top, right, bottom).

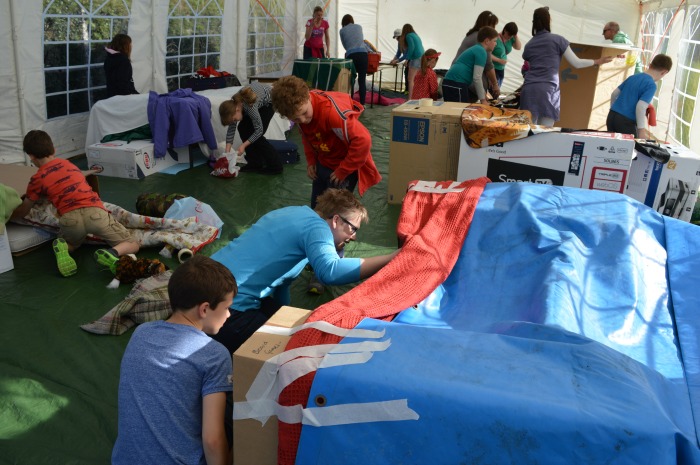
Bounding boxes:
165 0 223 91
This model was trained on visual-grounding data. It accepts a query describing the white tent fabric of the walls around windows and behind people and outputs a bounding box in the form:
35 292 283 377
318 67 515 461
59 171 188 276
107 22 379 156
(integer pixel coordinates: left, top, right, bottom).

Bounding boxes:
0 0 700 163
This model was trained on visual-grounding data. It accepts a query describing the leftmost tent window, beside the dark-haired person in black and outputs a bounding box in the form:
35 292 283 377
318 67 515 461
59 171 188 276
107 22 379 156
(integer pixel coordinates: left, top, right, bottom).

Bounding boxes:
43 0 132 119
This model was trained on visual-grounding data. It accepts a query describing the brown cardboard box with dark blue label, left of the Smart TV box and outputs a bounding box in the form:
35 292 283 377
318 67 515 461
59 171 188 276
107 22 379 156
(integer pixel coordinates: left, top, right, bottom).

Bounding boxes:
388 100 468 204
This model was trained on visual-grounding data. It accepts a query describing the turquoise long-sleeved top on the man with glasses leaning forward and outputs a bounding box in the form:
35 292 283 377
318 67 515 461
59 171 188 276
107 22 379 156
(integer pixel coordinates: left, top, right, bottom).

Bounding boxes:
211 206 360 311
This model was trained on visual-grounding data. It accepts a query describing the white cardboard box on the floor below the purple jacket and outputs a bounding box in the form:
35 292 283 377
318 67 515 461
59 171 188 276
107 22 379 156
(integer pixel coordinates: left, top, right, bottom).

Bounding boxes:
87 140 183 179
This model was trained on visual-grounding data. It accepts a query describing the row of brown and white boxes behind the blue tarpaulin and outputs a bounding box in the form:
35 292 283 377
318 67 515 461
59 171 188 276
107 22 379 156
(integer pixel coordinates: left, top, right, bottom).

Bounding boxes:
388 100 700 225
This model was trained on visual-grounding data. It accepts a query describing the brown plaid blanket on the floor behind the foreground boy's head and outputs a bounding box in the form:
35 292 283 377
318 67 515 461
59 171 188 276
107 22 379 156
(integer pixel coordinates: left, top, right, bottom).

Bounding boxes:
80 270 173 336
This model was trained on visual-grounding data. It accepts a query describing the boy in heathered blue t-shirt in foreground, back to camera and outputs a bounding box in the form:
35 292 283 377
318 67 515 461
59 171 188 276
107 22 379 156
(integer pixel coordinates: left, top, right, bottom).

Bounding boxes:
112 255 238 465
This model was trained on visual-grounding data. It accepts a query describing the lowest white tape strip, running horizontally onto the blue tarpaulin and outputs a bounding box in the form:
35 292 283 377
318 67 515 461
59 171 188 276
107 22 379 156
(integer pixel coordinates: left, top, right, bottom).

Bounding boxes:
233 399 420 427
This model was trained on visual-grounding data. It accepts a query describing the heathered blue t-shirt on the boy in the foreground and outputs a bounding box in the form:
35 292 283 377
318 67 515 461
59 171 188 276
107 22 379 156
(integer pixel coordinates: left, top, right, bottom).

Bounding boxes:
112 321 233 465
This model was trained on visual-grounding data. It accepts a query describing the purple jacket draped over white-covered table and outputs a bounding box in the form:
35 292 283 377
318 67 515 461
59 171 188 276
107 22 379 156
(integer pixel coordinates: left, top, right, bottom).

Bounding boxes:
148 89 217 158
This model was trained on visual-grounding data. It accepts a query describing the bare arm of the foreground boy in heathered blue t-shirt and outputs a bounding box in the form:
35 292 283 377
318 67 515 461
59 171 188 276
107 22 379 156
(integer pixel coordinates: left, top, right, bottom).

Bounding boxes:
202 392 232 465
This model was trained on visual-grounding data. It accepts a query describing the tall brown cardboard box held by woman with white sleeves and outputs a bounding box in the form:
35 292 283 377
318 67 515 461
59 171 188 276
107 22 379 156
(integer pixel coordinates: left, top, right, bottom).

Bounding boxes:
556 43 635 131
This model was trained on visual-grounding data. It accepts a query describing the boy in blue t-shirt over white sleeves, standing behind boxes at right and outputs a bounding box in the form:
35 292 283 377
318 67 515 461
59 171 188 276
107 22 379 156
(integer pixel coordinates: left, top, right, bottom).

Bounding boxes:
606 54 673 139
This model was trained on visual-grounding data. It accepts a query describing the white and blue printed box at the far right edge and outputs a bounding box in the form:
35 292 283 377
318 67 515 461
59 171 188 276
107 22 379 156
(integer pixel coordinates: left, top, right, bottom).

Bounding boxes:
626 144 700 221
